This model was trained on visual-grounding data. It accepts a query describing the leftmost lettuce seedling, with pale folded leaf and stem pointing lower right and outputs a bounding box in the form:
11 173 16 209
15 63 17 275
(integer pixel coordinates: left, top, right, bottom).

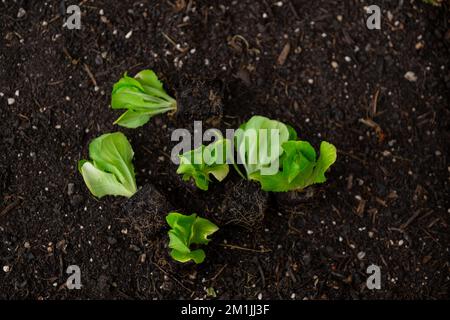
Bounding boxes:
78 132 137 198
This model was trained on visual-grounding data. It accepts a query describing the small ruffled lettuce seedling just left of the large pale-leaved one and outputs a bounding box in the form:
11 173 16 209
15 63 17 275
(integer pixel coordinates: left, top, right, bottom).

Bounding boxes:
177 139 231 191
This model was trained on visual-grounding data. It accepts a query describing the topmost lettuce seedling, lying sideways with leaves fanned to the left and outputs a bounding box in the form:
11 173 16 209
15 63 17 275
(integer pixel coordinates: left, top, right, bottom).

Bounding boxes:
111 70 177 128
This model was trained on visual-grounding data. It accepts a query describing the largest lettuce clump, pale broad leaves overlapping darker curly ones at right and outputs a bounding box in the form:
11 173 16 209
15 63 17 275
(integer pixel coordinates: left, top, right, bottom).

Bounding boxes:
235 116 336 192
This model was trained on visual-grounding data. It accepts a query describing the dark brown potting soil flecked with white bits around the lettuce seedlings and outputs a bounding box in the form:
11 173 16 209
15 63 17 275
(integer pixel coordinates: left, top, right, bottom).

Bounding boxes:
0 0 450 299
